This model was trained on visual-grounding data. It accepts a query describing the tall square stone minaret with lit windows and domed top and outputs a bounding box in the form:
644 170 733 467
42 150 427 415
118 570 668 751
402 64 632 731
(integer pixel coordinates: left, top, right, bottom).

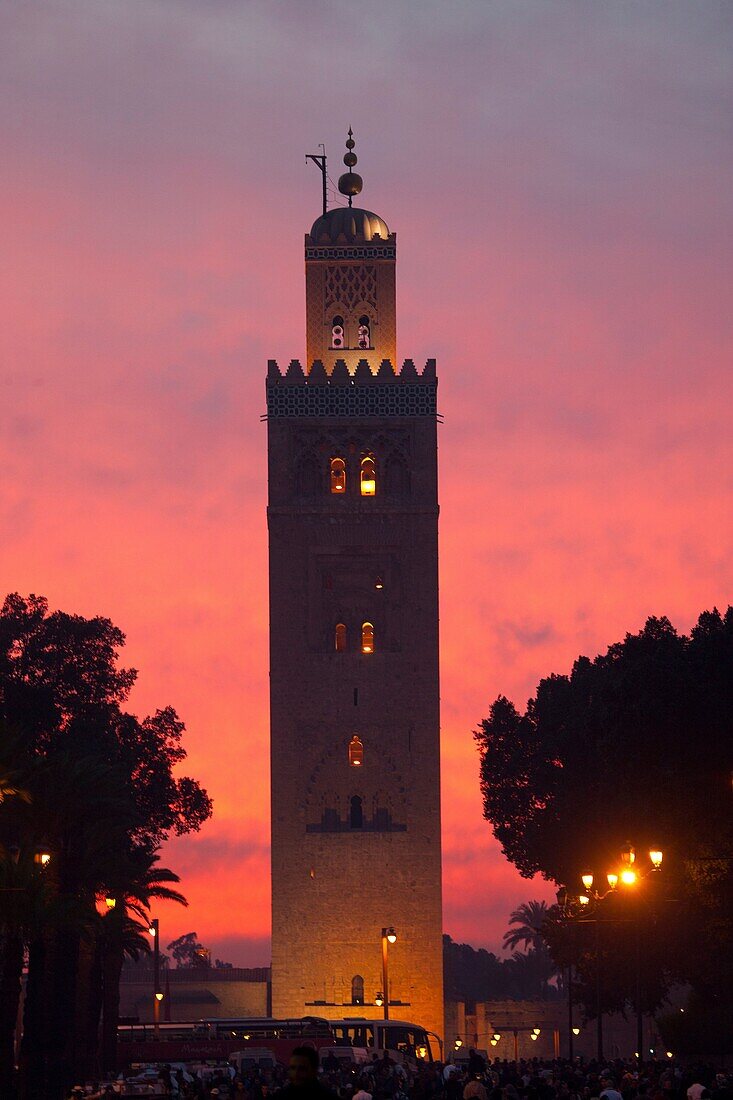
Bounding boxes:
266 133 442 1036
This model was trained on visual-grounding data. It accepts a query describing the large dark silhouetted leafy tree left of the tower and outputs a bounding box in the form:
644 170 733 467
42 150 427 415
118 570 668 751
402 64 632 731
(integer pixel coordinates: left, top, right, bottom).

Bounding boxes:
0 594 211 1100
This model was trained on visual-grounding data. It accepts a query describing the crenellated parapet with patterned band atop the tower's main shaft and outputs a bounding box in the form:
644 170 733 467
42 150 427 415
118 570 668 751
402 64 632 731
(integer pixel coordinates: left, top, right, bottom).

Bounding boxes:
265 359 438 418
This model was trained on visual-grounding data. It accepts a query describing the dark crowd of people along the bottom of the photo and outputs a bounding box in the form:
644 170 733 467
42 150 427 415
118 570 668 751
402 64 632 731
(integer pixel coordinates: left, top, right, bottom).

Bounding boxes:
65 1047 733 1100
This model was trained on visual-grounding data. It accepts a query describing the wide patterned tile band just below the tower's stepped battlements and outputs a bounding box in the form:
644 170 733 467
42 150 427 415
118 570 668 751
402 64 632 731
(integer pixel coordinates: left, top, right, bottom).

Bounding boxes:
266 382 438 417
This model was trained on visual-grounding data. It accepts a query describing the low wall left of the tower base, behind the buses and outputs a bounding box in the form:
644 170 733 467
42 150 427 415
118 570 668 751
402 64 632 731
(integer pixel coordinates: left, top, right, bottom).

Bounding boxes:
120 967 270 1023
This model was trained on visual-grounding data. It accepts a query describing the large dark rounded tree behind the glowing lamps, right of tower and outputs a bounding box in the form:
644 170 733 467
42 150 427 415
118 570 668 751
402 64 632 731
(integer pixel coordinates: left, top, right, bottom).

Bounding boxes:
475 607 733 1007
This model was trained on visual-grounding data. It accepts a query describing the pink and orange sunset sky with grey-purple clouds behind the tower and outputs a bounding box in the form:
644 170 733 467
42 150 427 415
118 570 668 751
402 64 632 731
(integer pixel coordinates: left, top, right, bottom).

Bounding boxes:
0 0 733 965
